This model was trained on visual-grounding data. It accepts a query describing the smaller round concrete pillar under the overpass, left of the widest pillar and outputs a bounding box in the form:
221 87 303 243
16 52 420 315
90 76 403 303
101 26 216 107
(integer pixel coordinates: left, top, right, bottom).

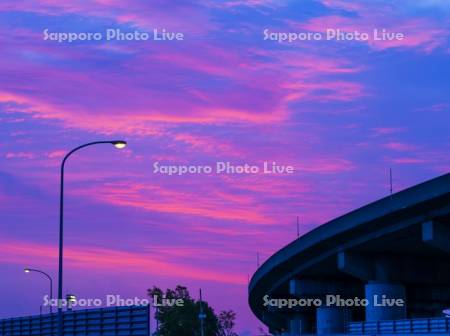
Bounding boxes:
316 307 348 335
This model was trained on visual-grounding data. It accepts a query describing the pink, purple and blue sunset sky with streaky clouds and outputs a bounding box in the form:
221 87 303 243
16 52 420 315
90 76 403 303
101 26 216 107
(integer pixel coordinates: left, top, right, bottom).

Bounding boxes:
0 0 450 335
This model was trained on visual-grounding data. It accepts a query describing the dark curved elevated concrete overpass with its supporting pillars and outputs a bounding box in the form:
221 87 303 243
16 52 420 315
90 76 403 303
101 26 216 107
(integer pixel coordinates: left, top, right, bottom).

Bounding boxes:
249 175 450 335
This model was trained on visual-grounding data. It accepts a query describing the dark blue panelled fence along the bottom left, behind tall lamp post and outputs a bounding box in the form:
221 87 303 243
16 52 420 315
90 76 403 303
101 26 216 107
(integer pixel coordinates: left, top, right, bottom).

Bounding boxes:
0 306 150 336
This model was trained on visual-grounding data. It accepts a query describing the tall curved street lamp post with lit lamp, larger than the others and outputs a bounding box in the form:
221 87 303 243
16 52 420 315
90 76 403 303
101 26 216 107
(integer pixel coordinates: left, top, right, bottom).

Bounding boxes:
58 140 127 336
